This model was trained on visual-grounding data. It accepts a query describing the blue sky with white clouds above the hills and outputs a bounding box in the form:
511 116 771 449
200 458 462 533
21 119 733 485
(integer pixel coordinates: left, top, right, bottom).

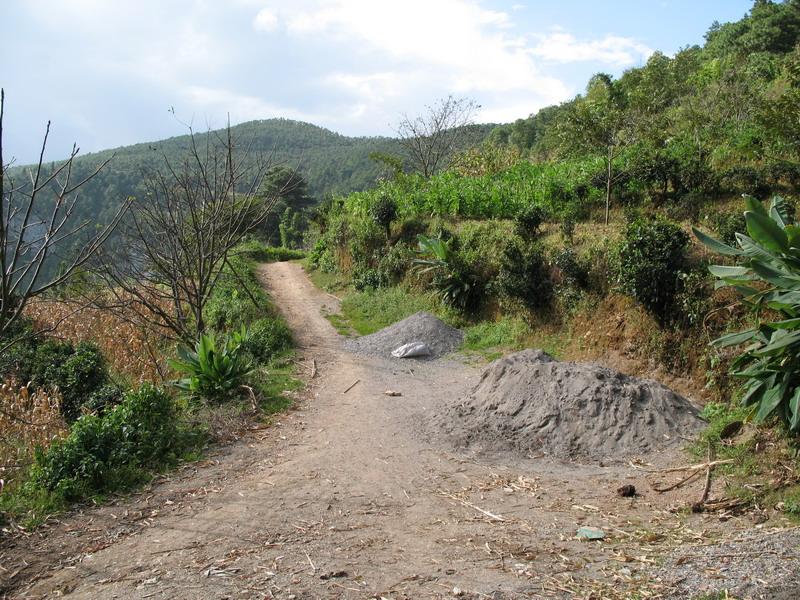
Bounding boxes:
0 0 752 163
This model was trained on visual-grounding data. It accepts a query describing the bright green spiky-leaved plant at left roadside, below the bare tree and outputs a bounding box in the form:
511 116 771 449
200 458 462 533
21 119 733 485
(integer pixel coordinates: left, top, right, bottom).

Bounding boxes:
169 325 253 401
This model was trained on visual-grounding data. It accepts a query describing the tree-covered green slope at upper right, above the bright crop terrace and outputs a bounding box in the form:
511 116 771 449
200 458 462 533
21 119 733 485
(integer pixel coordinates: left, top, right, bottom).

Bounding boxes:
490 0 800 205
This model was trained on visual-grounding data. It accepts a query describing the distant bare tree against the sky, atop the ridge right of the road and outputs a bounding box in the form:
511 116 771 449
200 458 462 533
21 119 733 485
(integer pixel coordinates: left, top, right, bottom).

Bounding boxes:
396 96 480 177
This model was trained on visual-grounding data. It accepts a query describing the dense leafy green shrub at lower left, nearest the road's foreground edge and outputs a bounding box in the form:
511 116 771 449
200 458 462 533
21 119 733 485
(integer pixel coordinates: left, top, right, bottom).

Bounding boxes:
27 385 192 501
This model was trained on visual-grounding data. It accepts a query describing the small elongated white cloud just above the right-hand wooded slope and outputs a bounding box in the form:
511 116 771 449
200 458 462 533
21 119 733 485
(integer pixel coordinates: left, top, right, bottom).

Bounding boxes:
531 30 653 67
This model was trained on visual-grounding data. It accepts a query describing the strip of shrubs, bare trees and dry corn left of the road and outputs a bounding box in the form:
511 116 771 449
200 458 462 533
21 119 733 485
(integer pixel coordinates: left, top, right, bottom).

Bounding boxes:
0 89 303 532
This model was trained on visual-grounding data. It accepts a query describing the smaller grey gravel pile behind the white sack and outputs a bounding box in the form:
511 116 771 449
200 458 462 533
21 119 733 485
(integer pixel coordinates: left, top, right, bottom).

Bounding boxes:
345 312 464 360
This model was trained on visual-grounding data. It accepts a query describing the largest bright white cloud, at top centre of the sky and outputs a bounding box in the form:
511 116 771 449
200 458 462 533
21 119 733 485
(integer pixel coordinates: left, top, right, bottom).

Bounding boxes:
253 0 570 120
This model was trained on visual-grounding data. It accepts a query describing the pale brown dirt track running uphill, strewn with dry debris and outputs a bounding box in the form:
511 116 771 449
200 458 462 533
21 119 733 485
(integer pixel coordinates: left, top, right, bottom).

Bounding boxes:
0 263 797 600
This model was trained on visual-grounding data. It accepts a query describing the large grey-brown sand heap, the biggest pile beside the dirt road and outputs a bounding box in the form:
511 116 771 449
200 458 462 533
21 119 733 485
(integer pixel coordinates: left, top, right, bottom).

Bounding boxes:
436 350 703 460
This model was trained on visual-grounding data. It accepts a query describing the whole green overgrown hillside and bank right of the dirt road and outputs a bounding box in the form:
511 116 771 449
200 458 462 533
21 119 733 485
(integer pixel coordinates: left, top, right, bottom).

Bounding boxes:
306 1 800 513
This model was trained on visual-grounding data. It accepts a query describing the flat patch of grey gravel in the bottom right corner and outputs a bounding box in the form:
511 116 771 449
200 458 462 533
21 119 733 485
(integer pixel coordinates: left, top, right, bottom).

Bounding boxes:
652 529 800 600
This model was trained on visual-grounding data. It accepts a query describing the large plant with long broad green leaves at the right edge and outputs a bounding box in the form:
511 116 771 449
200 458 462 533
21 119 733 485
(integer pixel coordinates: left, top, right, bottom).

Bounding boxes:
693 196 800 432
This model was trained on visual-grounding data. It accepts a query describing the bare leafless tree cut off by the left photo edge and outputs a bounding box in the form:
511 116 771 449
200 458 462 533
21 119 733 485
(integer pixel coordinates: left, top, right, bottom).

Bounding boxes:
0 90 129 352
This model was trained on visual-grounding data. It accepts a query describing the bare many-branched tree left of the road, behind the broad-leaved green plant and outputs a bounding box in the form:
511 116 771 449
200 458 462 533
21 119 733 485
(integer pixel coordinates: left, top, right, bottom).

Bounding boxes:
96 122 288 343
